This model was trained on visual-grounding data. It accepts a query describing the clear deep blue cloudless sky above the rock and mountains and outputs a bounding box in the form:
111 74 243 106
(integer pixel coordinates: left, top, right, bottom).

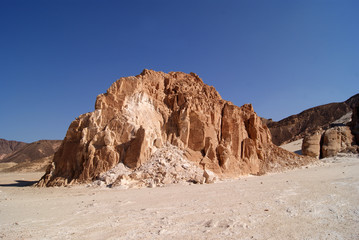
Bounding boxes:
0 0 359 142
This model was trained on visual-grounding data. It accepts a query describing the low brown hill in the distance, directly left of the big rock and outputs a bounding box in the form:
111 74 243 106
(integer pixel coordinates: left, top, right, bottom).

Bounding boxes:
0 140 62 171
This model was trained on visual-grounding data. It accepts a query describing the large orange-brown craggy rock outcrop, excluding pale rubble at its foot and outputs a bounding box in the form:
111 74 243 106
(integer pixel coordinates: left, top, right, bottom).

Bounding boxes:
38 70 312 186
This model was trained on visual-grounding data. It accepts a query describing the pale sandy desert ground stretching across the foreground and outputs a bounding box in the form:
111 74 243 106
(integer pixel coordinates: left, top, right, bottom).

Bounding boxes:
0 155 359 239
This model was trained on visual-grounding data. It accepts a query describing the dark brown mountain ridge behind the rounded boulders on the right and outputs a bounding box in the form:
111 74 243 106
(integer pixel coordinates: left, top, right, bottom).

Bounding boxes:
262 94 359 145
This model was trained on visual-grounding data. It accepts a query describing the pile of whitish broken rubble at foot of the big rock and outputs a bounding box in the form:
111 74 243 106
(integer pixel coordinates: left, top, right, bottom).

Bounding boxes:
90 144 218 188
